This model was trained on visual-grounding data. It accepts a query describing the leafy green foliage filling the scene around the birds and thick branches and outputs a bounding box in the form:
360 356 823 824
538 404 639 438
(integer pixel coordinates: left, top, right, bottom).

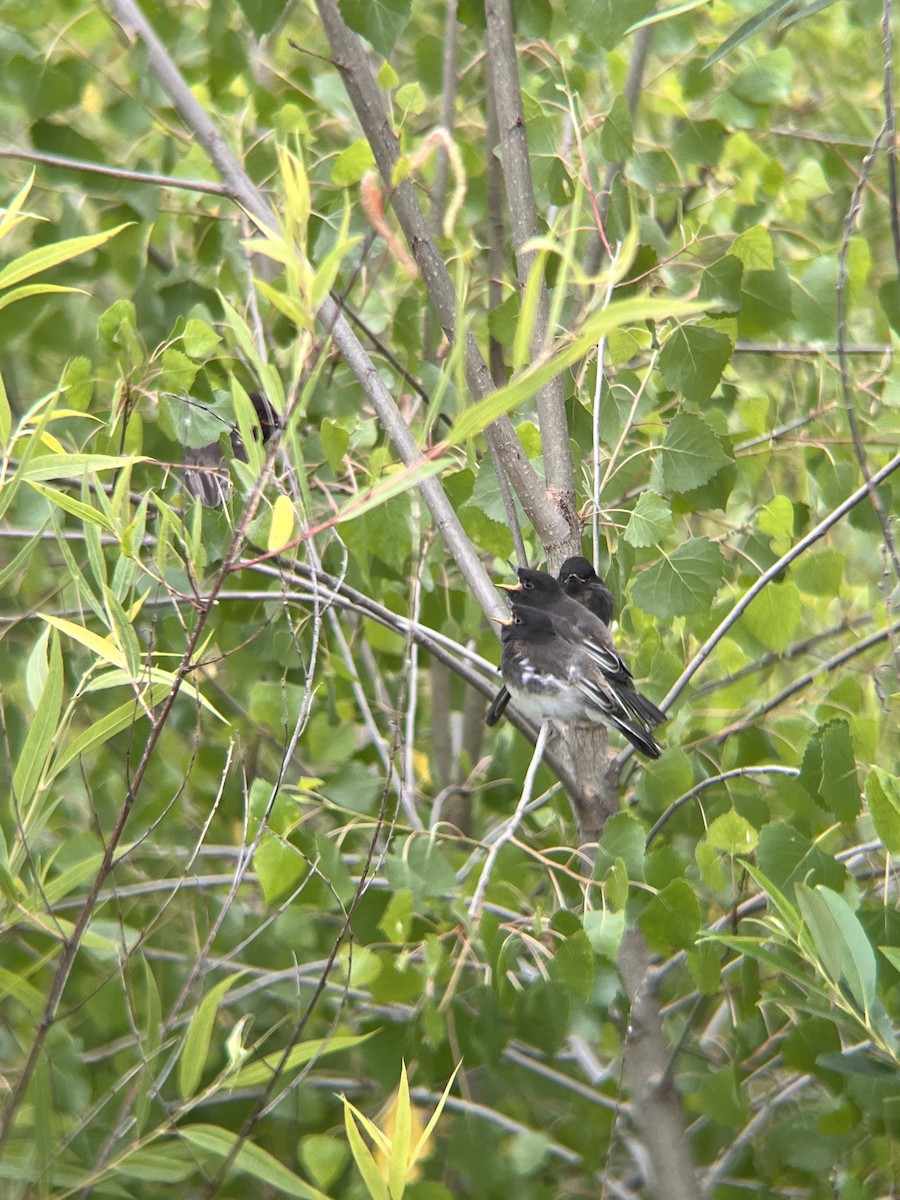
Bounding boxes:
0 0 900 1200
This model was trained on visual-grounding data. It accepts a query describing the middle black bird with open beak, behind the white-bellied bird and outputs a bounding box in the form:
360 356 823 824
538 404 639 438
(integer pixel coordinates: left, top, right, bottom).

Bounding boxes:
485 566 666 730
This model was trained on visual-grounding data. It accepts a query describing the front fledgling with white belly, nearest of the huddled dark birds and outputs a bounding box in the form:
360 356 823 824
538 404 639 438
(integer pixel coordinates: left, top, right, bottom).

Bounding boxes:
500 604 661 758
